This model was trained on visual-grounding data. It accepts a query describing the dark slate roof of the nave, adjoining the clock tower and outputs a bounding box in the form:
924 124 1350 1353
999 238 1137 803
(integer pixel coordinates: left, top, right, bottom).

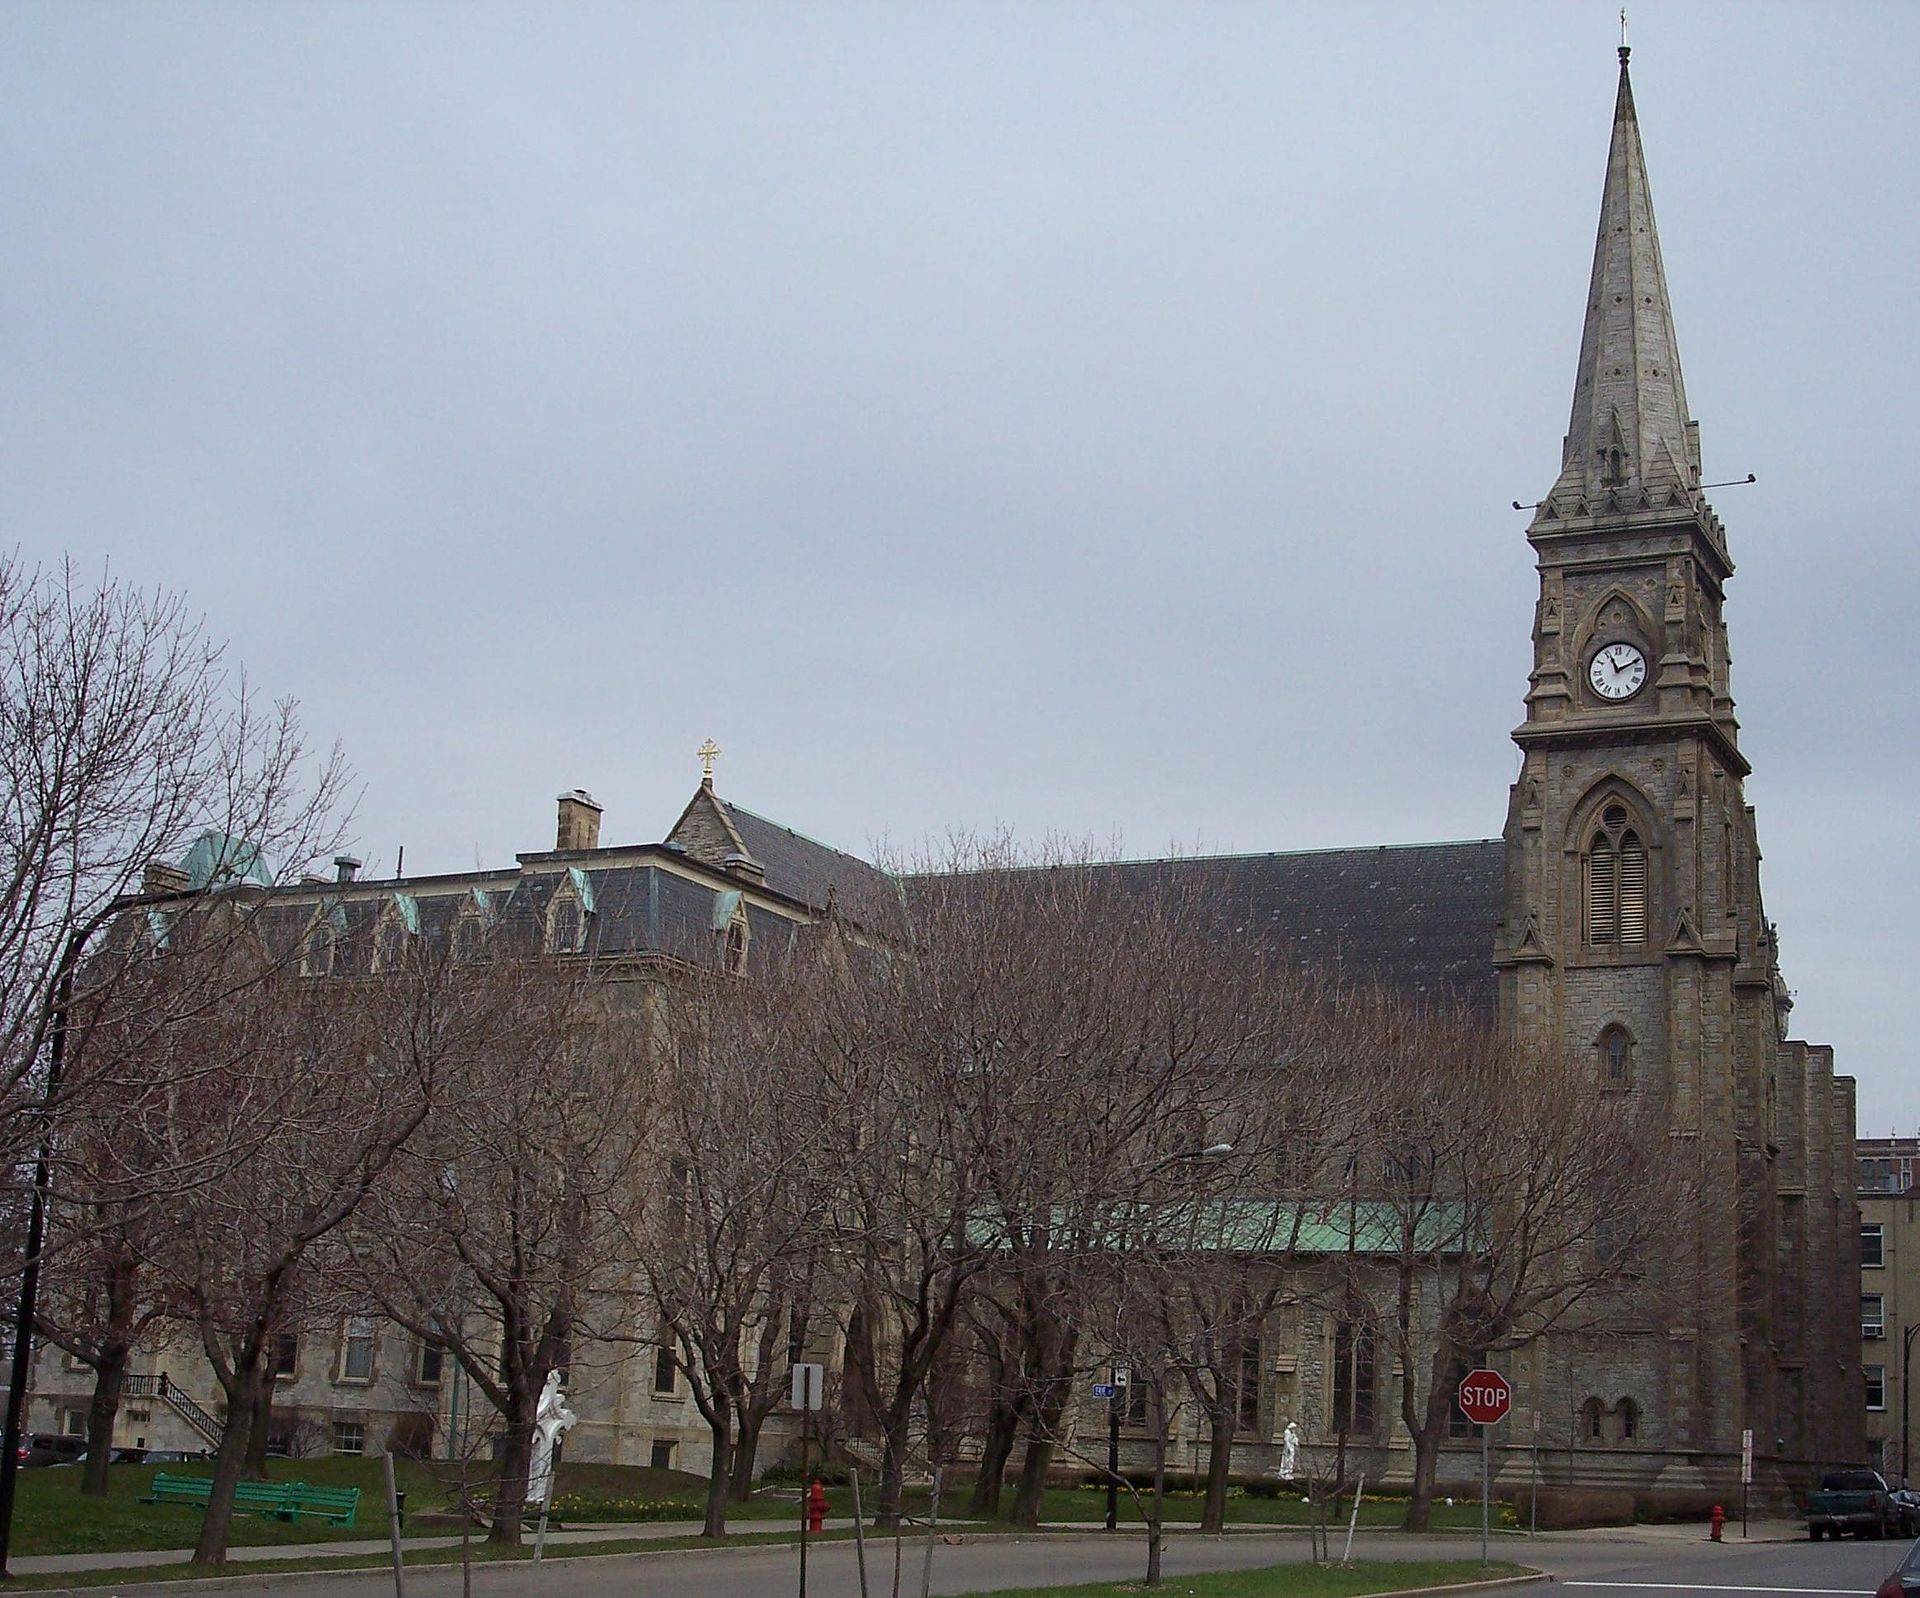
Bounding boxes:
1106 837 1505 1014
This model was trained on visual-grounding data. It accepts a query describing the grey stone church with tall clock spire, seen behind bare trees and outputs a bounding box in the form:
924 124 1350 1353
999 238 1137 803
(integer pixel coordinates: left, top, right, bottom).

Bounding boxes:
35 48 1864 1492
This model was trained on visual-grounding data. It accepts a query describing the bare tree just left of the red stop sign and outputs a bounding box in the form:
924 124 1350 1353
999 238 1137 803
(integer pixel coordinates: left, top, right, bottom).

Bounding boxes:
1352 999 1690 1531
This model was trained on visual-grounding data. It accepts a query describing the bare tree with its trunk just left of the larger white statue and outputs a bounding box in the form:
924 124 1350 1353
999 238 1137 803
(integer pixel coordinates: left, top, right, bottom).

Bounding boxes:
353 935 653 1544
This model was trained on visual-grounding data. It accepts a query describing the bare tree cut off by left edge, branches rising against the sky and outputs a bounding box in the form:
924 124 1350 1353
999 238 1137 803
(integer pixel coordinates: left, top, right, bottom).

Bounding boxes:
0 555 346 1172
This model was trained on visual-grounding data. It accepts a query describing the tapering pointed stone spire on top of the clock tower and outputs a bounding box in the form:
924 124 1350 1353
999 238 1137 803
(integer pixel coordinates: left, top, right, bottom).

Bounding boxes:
1549 44 1699 501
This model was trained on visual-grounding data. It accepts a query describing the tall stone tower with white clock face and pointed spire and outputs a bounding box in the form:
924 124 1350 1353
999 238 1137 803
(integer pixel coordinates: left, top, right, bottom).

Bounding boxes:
1496 48 1860 1487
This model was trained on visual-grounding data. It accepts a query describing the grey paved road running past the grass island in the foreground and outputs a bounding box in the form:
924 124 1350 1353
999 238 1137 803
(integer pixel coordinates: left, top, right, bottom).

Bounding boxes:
52 1531 1905 1598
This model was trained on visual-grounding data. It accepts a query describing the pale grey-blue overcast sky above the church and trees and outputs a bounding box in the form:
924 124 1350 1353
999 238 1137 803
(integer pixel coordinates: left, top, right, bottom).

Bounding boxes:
0 0 1920 1131
